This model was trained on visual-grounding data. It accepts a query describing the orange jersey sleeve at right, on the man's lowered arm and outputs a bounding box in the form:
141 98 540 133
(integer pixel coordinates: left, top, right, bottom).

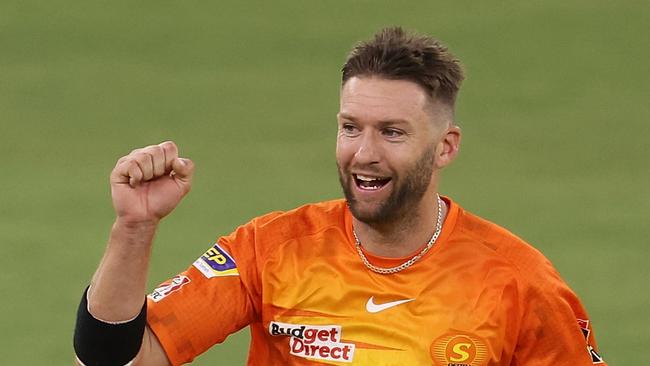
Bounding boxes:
512 263 607 366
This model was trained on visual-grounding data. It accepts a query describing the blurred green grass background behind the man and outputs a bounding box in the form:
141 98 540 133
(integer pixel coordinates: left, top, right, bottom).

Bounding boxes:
0 0 650 365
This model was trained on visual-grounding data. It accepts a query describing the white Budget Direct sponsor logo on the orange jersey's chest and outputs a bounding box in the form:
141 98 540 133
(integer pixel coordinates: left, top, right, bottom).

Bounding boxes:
269 322 355 362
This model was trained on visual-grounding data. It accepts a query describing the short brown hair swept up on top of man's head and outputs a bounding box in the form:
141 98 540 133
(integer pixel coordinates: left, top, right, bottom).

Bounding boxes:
342 27 464 108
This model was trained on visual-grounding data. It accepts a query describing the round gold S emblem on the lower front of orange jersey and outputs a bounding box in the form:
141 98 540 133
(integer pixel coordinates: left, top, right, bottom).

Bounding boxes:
431 332 488 366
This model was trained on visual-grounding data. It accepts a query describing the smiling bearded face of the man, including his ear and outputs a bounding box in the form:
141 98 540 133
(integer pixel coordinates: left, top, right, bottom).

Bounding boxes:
336 77 460 224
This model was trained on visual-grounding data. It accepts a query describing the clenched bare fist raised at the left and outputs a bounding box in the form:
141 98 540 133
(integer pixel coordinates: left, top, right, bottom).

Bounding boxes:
111 141 194 223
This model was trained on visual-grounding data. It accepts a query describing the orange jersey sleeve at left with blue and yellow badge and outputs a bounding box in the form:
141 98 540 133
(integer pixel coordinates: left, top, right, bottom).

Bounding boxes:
147 216 270 365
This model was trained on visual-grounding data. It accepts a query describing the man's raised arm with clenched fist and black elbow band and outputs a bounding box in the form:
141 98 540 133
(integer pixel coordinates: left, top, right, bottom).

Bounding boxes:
74 141 194 366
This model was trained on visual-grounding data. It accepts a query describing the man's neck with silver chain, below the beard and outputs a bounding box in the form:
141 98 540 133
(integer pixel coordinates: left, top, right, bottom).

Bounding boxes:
352 196 448 258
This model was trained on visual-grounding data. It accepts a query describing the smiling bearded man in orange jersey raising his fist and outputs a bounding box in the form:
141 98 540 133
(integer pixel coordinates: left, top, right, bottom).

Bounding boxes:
75 28 604 366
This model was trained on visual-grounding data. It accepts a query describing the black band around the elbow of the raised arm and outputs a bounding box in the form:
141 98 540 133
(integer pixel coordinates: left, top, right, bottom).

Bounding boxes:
74 287 147 366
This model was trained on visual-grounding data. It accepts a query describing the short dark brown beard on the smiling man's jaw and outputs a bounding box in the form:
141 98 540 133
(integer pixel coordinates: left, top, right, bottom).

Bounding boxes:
337 149 434 224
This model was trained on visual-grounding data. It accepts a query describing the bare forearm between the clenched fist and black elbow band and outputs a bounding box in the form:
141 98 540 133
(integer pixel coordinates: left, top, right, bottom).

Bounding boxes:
88 219 157 322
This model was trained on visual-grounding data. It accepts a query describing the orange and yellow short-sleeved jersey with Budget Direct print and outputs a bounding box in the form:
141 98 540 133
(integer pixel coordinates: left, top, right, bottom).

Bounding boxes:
148 198 605 366
